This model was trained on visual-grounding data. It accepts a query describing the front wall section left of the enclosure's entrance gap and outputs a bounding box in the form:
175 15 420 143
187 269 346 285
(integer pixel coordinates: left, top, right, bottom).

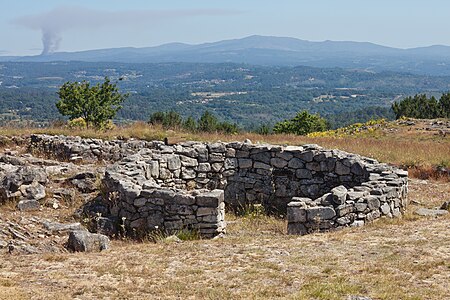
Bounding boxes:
103 165 225 237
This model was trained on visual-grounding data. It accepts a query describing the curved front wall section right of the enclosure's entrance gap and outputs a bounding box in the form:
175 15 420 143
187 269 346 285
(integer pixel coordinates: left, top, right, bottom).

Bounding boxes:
287 169 408 235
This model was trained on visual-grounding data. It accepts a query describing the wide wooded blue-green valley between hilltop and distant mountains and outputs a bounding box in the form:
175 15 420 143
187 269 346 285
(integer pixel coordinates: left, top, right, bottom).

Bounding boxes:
0 62 450 129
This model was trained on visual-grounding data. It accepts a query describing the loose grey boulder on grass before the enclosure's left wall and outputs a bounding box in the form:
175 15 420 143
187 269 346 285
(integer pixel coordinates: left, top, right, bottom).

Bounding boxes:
67 230 109 252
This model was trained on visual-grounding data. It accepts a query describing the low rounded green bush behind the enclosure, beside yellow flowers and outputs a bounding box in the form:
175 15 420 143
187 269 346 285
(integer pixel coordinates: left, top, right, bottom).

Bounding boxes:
273 110 328 135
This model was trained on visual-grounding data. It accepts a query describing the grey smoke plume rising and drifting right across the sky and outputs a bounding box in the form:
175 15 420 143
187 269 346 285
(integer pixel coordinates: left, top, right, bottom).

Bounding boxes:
12 7 240 55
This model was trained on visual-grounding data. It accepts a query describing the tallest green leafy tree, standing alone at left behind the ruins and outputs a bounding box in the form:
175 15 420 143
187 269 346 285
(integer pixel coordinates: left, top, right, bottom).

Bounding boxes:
56 77 128 128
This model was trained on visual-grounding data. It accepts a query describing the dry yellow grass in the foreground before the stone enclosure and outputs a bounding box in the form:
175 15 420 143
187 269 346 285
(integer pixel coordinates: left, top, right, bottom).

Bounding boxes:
0 180 450 300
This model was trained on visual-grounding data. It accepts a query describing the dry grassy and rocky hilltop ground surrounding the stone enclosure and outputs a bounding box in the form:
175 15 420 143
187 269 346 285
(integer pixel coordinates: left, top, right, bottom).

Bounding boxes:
0 120 450 299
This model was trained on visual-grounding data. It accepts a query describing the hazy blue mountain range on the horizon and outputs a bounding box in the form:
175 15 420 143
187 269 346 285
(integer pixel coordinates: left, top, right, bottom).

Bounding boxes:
0 35 450 76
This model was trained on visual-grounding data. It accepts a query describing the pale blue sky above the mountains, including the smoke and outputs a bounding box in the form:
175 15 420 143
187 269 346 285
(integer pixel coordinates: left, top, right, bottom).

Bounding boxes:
0 0 450 55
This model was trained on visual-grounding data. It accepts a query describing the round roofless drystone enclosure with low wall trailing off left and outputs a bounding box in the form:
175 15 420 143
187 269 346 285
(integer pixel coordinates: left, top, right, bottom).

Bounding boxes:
29 135 408 237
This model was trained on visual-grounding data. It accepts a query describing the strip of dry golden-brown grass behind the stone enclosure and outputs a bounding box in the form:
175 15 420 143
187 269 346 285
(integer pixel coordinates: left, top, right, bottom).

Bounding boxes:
0 122 450 171
